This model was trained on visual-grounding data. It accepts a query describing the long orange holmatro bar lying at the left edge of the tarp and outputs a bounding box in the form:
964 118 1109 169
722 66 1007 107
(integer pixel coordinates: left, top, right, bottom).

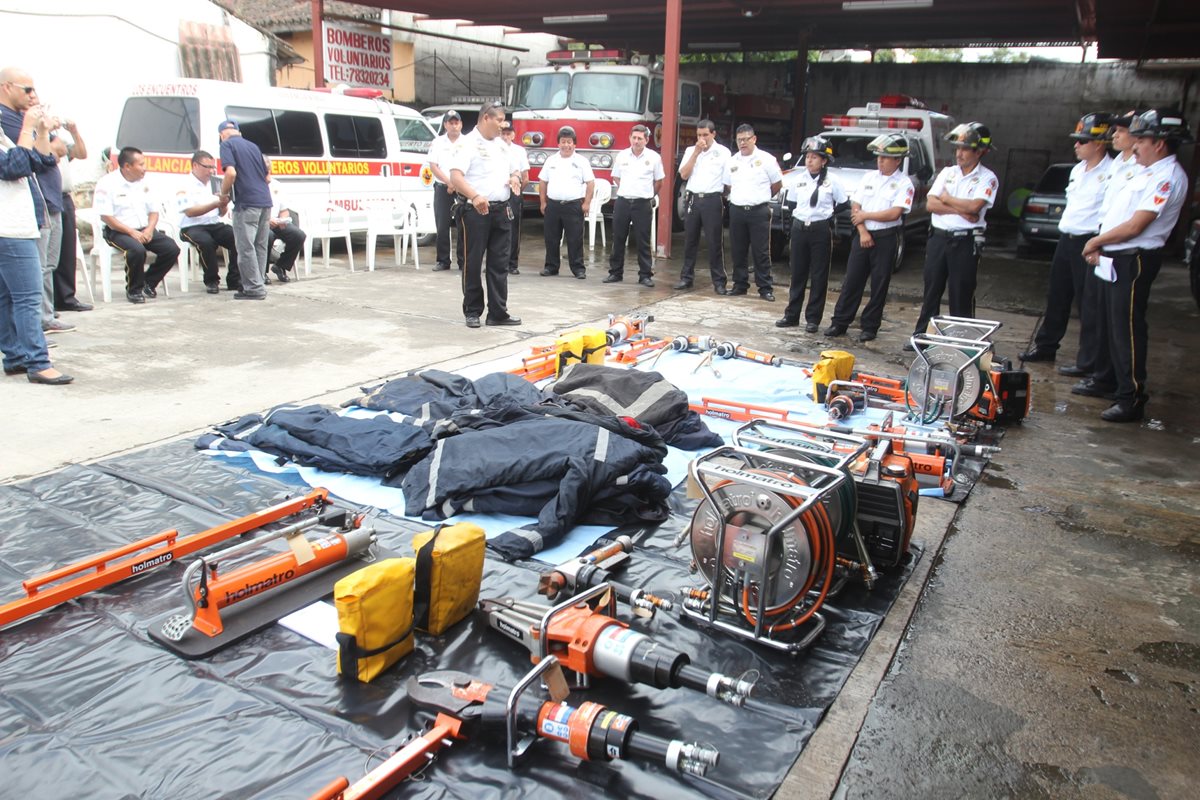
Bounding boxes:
0 488 329 626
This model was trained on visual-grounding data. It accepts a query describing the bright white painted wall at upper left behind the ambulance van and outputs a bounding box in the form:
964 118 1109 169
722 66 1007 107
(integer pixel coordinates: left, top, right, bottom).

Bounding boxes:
0 0 271 181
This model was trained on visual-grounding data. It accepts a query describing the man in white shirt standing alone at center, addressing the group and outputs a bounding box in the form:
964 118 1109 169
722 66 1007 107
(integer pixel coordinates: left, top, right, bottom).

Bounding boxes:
450 101 521 327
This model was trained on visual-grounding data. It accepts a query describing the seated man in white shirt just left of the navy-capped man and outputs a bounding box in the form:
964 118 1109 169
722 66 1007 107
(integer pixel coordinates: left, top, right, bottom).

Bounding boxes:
176 150 241 294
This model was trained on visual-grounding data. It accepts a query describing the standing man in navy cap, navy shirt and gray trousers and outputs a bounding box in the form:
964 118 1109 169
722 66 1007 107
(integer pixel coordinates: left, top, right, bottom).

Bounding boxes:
217 120 271 300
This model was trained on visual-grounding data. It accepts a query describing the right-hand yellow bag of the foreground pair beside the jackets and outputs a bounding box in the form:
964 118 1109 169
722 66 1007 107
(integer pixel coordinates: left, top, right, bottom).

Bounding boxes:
413 522 487 636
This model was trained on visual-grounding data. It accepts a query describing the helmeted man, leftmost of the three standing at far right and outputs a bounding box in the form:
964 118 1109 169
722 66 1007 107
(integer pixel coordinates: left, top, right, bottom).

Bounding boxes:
1020 114 1112 374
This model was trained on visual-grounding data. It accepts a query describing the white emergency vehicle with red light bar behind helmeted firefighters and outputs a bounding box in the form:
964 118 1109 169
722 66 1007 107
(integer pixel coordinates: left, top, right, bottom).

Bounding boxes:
770 95 955 269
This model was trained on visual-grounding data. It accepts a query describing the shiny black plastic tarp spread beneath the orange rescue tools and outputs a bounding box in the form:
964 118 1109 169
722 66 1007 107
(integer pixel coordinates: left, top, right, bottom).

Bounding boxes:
0 441 911 800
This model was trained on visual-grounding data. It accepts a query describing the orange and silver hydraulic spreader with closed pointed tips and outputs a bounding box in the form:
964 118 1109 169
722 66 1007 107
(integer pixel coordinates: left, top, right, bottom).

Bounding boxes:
479 583 757 706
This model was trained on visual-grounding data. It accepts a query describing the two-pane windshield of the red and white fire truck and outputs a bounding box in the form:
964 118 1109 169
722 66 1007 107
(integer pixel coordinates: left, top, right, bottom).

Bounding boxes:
514 71 649 114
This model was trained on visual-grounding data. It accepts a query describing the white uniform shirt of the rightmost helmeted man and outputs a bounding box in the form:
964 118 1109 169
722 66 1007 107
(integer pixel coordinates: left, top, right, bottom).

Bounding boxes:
1100 156 1188 252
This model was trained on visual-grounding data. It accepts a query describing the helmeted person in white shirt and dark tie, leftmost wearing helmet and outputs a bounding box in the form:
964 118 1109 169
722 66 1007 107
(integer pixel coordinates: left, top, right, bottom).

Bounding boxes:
775 136 848 333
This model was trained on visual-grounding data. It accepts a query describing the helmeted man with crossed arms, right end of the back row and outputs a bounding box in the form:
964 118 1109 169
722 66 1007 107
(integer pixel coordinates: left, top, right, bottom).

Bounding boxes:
905 122 1000 350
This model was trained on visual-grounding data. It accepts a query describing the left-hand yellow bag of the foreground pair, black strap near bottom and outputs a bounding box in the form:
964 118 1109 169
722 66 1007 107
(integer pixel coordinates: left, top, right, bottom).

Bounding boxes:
334 559 416 682
